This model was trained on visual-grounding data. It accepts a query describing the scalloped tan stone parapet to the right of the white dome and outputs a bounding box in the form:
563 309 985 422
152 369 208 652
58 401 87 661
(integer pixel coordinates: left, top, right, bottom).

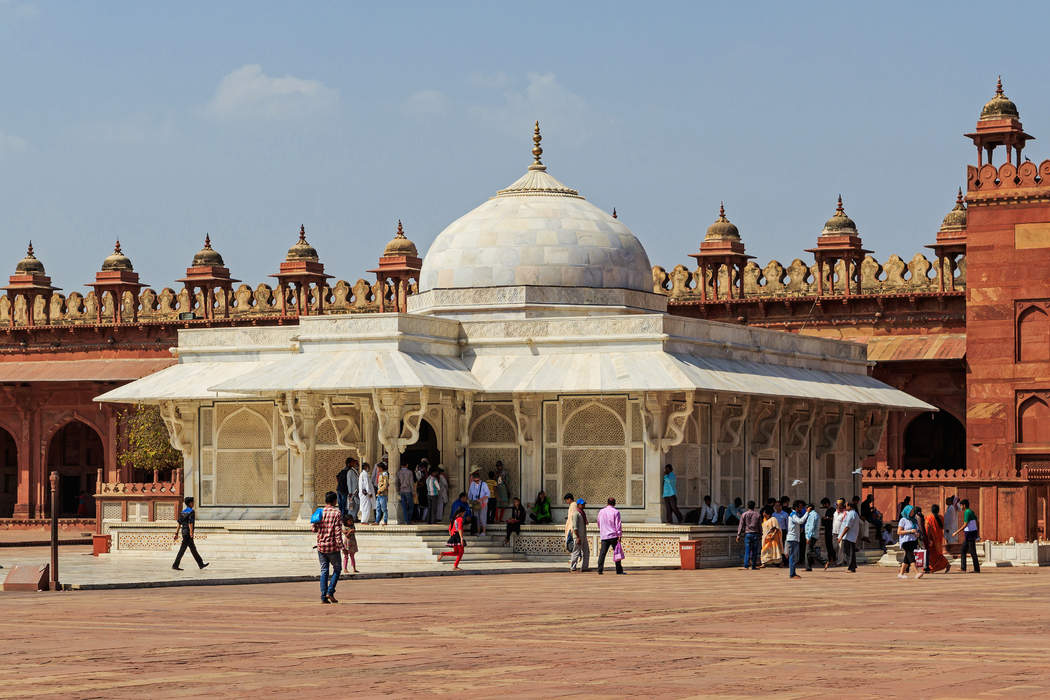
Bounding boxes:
652 253 966 300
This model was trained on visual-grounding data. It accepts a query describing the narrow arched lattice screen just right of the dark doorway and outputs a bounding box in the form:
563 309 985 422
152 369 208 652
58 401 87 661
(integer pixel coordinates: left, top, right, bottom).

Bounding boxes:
467 403 520 503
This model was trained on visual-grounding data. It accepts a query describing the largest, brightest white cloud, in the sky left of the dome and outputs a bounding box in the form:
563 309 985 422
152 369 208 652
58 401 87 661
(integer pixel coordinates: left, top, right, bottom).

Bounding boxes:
205 63 338 120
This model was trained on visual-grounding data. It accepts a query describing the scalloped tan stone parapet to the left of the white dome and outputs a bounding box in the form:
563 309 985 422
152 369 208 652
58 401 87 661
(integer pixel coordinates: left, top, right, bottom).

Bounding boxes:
0 279 416 326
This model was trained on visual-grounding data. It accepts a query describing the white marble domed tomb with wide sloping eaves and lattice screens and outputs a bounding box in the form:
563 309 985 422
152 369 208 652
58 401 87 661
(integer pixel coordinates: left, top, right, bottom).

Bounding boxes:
99 126 932 556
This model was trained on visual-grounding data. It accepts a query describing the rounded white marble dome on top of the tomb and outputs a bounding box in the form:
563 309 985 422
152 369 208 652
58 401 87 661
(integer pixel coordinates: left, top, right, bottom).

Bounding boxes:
419 157 652 292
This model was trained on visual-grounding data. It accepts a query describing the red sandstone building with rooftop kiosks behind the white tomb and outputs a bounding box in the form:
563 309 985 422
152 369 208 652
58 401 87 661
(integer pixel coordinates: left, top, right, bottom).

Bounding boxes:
0 80 1050 539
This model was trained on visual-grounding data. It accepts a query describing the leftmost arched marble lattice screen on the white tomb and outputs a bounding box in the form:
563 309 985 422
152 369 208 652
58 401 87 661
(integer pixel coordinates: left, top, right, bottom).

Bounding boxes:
200 402 289 506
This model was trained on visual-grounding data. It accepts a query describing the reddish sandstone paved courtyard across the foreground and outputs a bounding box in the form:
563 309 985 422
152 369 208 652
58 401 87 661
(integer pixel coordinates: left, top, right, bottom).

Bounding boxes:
0 567 1050 698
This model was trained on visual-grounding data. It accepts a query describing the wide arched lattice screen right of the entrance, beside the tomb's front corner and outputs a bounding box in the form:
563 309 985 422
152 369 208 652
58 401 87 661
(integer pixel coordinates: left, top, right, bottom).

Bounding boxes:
543 397 645 508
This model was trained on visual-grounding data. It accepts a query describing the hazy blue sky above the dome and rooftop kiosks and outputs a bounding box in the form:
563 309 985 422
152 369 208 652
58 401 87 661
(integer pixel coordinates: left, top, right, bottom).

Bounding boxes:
0 0 1050 290
